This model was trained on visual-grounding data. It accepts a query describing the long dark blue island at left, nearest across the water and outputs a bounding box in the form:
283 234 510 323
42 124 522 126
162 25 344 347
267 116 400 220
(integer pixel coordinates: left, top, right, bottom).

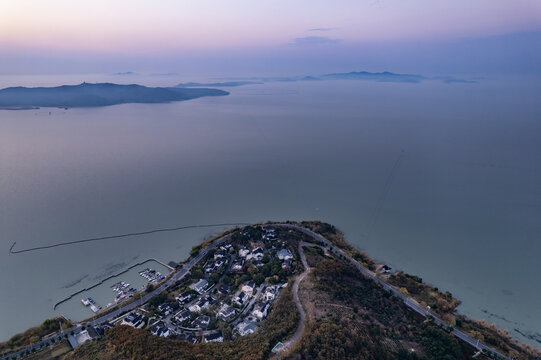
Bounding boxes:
0 83 229 108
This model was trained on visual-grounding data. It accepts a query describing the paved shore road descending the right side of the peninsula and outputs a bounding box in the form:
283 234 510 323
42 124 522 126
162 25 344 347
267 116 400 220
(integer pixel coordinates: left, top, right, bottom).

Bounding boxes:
275 224 512 360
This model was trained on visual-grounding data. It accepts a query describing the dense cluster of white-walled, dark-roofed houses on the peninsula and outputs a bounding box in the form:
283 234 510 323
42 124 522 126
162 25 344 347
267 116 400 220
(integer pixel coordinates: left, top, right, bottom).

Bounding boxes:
117 227 293 343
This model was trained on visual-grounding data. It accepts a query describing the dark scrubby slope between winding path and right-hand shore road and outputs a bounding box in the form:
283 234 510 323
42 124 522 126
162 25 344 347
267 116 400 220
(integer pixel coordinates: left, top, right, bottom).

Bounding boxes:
290 243 474 360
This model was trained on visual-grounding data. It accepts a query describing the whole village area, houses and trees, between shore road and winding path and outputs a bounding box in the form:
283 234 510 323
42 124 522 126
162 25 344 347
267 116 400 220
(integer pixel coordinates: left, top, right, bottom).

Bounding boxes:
110 226 297 343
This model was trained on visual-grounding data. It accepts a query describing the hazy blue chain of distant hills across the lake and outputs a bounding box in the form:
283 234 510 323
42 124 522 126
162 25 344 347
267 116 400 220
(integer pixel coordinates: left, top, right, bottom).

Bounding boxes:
0 71 476 110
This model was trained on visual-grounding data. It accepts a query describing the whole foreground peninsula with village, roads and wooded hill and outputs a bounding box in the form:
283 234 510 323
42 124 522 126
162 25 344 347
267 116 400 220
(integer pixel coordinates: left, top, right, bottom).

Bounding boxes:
0 221 541 360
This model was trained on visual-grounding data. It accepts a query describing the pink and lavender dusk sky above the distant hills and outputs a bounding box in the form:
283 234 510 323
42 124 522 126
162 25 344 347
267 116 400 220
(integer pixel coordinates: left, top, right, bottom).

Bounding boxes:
0 0 541 75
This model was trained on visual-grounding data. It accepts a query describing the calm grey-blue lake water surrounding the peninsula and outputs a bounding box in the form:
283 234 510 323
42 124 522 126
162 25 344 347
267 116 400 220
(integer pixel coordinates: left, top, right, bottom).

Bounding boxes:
0 77 541 347
